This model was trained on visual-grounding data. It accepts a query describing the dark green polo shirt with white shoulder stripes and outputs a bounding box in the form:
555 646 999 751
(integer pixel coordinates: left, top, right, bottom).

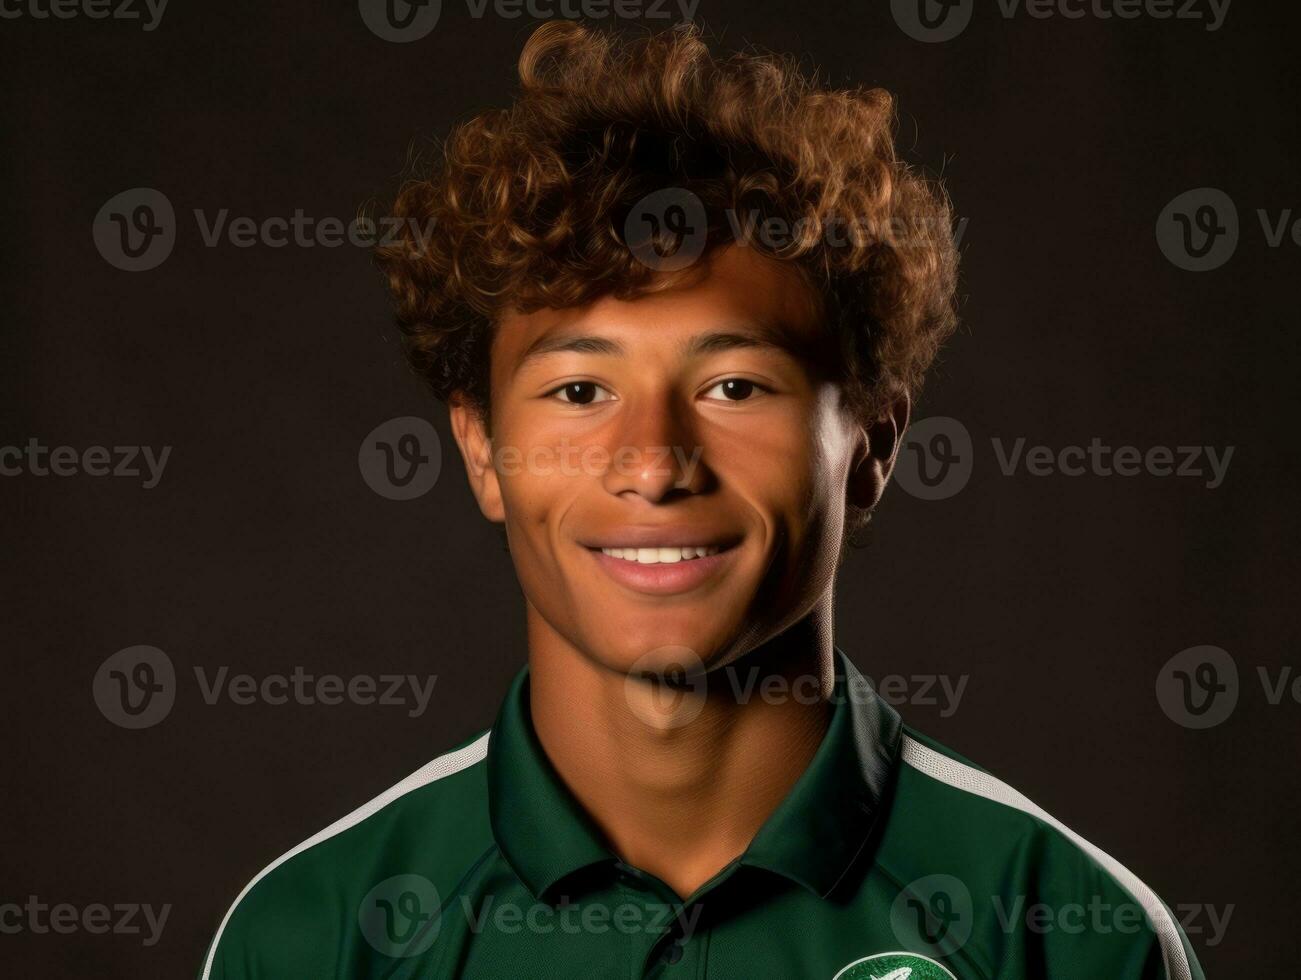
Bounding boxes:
202 652 1203 980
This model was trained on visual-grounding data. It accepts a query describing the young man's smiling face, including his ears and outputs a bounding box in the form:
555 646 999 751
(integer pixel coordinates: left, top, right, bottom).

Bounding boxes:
454 247 889 672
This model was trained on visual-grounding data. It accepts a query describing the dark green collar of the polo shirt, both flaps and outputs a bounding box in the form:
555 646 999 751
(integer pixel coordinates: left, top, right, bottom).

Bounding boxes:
488 651 902 898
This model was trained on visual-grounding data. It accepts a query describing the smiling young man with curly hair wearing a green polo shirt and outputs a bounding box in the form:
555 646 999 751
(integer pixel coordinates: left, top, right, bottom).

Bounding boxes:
203 17 1201 980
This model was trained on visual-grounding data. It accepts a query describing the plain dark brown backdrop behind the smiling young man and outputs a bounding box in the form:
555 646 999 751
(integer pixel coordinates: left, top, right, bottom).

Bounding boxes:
0 0 1301 977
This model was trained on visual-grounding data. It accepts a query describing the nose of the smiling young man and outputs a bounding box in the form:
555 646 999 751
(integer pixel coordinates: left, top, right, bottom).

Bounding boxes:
604 396 709 504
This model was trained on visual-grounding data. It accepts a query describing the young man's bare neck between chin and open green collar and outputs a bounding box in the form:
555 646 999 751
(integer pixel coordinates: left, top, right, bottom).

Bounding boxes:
528 603 834 897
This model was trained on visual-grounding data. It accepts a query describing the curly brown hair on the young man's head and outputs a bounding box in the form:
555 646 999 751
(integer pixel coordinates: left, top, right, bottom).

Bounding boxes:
376 21 958 424
